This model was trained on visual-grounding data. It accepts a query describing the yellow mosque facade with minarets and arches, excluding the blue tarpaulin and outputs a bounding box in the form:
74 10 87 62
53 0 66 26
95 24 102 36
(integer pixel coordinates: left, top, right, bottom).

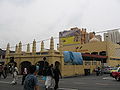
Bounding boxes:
5 27 120 76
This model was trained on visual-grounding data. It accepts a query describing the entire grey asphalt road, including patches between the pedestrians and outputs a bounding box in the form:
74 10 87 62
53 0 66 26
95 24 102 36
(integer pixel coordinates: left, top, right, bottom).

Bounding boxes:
0 75 120 90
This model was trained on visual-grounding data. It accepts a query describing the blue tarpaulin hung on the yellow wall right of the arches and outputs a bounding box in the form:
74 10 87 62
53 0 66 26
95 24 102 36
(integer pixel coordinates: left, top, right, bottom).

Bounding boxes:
64 51 83 65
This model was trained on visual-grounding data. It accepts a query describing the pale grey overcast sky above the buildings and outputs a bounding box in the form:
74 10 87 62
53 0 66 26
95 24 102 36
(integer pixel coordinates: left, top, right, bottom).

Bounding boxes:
0 0 120 48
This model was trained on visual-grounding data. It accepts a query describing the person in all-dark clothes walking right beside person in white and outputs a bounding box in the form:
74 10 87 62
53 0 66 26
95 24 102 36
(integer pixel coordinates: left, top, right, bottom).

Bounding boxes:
53 66 62 90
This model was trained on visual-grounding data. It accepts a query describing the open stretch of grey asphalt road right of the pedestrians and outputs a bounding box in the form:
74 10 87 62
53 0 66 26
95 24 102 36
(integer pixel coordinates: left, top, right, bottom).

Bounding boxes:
60 75 120 90
